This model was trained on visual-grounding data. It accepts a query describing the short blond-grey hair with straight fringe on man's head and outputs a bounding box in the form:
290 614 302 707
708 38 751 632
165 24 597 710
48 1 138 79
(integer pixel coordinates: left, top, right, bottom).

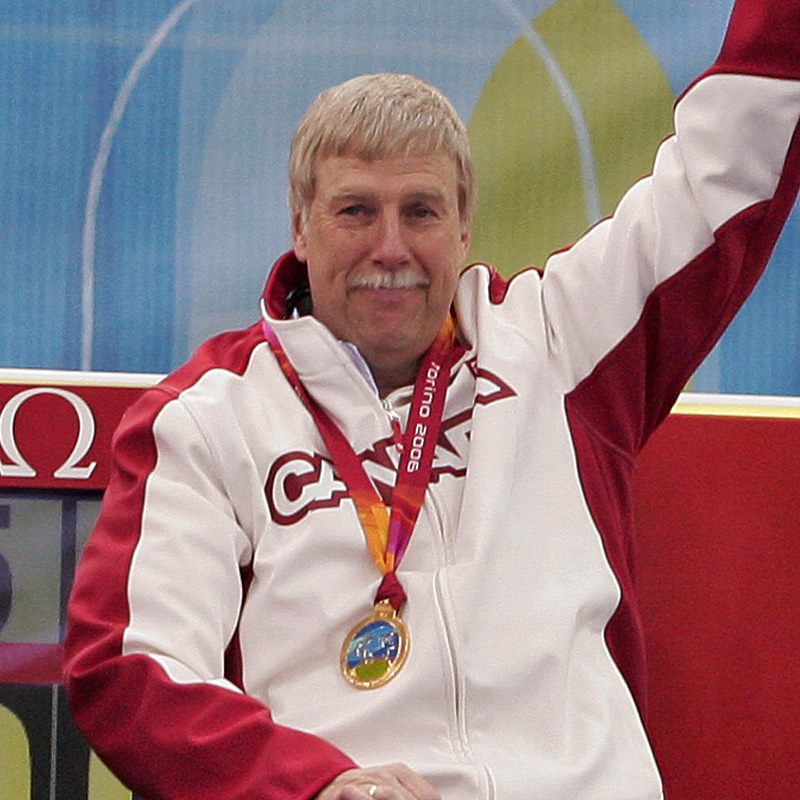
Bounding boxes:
289 73 476 220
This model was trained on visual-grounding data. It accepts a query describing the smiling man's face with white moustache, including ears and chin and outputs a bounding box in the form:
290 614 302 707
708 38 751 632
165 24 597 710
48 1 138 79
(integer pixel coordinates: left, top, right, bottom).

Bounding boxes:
293 153 469 378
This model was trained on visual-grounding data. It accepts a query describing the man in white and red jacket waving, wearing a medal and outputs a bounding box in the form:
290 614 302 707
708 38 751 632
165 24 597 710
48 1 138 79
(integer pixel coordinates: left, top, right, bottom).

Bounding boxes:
67 0 800 800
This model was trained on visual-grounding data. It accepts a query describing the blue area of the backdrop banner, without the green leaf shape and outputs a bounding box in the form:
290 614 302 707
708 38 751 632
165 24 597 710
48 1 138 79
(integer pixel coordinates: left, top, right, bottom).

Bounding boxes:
0 0 800 395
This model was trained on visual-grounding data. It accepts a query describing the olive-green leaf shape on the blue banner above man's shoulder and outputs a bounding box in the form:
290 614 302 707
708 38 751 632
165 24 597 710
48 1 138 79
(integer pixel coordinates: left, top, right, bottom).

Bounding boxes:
469 0 674 276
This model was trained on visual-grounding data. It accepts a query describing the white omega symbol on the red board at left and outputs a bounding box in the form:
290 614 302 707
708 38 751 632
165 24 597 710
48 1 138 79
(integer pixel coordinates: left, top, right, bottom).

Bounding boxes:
0 386 97 480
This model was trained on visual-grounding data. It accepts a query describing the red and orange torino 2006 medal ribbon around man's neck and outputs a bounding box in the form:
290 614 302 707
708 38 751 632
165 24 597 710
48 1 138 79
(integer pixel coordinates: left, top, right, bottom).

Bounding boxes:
262 316 466 612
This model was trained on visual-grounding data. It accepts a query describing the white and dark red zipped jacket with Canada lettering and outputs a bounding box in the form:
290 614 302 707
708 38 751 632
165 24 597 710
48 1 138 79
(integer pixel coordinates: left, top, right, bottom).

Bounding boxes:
67 0 800 800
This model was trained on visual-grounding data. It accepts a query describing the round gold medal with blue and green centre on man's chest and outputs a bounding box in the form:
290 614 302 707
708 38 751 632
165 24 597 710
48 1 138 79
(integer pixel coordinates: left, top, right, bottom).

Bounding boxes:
339 600 411 689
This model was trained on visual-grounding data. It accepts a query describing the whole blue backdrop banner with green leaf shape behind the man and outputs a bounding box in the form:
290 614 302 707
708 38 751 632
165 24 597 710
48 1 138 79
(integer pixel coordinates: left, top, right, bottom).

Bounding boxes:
0 0 800 394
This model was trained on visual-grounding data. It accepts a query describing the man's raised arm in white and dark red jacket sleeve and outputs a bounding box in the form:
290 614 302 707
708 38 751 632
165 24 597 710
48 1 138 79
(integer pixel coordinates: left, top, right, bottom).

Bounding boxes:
506 0 800 454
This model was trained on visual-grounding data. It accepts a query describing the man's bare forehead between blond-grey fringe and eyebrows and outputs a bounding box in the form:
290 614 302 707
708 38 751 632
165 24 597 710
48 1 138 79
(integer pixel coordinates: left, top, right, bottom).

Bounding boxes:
315 152 458 201
